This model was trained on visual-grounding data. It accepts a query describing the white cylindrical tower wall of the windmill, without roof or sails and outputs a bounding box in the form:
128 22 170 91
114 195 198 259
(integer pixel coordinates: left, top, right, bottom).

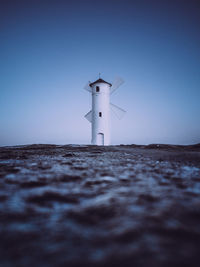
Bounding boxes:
92 83 110 145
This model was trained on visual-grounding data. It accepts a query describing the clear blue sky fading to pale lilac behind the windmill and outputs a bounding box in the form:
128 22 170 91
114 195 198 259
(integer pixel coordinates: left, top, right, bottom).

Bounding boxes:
0 0 200 145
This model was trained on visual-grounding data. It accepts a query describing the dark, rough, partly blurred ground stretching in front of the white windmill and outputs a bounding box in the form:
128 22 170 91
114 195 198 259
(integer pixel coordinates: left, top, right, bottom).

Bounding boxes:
0 145 200 267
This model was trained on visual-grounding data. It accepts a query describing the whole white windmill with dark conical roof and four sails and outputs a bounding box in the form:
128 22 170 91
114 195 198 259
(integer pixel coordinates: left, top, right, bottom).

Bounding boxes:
84 77 125 146
